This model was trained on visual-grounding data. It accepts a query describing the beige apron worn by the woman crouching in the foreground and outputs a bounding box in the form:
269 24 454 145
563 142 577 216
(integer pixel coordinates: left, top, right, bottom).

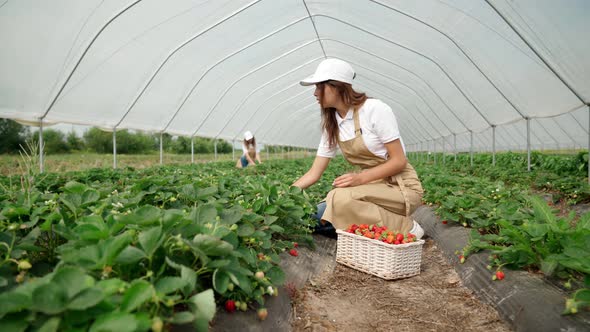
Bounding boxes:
322 109 424 233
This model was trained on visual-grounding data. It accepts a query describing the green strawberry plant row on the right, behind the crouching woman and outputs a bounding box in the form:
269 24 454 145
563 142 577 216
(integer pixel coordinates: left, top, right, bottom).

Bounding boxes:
417 157 590 313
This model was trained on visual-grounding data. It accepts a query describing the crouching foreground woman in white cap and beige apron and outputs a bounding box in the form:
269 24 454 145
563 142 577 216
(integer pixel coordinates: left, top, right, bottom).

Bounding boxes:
293 59 424 239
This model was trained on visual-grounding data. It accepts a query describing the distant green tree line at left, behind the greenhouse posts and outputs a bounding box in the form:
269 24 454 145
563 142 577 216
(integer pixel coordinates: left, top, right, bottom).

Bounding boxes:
0 119 232 154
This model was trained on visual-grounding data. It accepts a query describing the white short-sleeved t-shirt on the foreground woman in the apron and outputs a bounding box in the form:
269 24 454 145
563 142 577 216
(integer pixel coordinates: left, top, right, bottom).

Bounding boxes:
317 98 406 159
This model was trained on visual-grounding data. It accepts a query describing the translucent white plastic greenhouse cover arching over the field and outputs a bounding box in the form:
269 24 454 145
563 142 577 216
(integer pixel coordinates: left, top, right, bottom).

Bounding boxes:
0 0 590 151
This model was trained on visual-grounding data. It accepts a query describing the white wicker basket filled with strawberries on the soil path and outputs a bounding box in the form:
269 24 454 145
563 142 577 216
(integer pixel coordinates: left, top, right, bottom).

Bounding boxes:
336 229 424 280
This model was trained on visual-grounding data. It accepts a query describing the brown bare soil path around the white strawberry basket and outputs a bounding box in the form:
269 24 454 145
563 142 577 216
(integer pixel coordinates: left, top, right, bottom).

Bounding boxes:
291 239 511 332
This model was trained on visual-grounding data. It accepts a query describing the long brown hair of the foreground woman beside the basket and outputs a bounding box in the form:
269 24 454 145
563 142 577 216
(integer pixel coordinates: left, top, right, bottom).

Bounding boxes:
318 81 368 148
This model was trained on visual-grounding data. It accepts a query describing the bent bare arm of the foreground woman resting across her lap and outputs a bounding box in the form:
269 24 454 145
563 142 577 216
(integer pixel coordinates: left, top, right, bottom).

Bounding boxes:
334 139 408 188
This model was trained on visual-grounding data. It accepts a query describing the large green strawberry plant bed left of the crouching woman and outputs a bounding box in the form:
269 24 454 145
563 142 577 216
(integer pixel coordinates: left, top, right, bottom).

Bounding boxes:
0 161 344 331
